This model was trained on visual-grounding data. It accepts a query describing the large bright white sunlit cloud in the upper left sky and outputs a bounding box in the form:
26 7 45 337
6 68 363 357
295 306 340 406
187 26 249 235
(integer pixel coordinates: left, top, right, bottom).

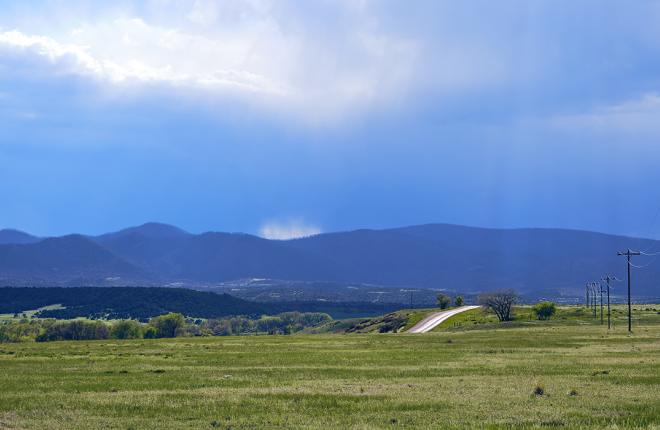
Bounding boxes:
0 0 417 121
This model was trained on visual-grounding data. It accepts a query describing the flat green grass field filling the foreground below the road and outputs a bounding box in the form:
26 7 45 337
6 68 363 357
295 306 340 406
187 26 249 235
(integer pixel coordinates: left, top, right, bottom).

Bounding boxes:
0 311 660 429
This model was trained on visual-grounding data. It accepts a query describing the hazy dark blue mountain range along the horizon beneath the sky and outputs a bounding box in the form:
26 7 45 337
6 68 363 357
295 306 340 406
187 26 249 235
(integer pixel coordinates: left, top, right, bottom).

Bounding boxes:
0 223 660 297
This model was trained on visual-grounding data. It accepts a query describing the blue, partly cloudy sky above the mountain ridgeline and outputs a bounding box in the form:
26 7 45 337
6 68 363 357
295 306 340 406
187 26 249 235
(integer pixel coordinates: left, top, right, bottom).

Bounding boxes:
0 0 660 239
